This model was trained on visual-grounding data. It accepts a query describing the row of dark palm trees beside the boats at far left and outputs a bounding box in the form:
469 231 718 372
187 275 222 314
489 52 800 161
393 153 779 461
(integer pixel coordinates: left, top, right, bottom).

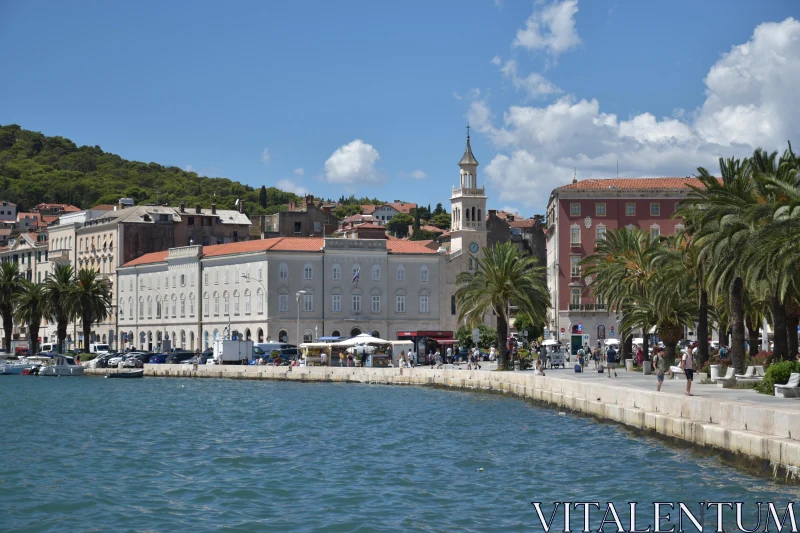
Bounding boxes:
0 262 111 353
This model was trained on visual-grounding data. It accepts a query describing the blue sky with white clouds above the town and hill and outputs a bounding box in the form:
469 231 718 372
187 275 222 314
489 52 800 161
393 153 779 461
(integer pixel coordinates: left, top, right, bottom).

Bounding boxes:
0 0 800 216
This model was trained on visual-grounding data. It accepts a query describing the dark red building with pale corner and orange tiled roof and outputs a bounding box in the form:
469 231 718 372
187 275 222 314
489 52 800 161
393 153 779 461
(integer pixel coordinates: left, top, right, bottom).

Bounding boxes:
545 178 700 353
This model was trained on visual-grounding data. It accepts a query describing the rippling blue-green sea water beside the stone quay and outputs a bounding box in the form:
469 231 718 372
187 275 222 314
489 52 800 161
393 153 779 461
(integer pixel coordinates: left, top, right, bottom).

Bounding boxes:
0 376 800 532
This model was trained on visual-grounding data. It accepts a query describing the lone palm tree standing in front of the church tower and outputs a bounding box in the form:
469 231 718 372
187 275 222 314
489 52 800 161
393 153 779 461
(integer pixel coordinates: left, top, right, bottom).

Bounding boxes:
455 242 550 368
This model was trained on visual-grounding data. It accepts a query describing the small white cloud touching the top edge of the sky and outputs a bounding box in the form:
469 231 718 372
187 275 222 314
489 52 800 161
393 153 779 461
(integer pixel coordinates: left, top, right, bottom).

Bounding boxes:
513 0 581 57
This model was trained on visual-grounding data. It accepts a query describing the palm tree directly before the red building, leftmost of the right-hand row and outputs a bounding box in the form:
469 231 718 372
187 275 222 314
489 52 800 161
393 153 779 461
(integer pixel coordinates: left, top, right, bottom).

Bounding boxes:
581 228 659 359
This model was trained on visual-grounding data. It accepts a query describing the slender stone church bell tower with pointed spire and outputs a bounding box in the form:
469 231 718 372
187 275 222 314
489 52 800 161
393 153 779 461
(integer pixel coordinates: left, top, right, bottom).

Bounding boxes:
450 126 487 264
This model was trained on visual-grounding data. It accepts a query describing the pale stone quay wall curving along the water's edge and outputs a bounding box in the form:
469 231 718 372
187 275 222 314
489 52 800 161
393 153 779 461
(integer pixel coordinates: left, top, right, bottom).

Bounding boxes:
87 364 800 482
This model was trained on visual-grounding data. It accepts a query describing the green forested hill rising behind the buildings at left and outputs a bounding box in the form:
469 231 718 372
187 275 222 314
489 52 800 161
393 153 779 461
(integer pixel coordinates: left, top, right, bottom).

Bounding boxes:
0 124 299 214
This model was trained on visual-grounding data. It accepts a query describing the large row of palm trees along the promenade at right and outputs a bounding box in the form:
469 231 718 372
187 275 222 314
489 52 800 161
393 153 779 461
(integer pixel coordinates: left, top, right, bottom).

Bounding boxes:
582 144 800 373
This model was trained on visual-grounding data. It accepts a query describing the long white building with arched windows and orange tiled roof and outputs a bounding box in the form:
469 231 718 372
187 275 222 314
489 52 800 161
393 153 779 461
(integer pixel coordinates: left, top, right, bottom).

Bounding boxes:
117 237 442 350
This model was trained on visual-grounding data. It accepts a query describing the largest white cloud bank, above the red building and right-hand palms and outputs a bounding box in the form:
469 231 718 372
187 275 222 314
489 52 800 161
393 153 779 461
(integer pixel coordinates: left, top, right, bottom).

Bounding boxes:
467 18 800 209
